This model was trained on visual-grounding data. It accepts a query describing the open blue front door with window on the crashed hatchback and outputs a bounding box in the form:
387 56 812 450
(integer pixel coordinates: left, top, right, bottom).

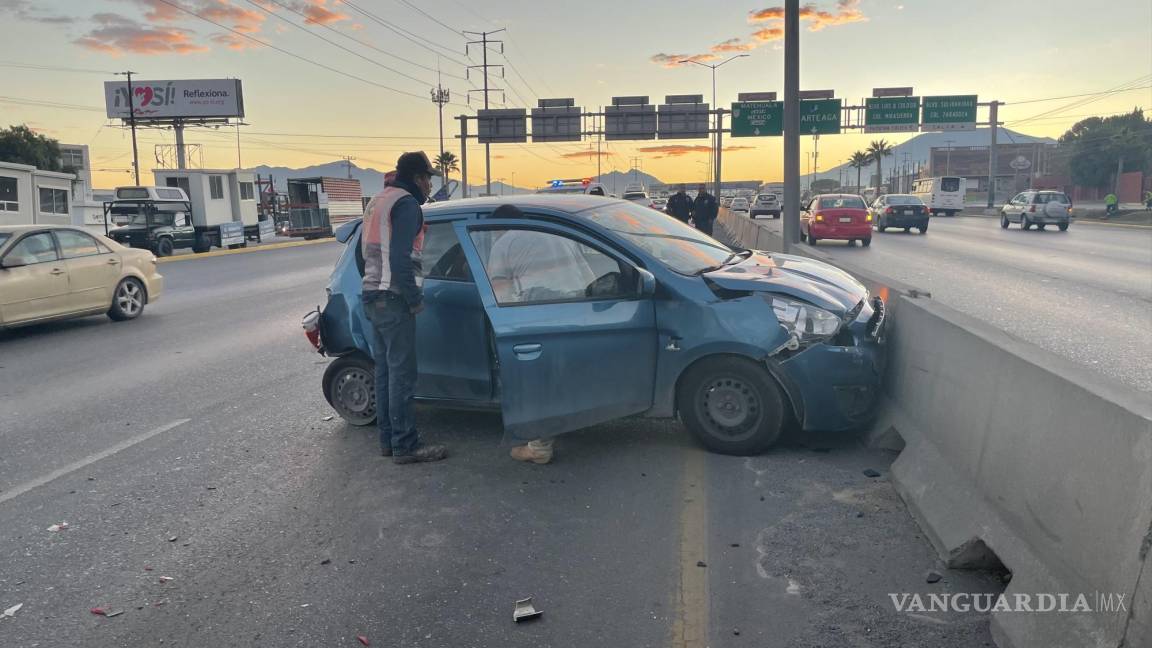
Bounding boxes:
455 219 658 440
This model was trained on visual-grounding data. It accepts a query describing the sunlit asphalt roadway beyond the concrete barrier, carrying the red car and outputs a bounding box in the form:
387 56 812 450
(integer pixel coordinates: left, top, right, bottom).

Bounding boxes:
759 217 1152 392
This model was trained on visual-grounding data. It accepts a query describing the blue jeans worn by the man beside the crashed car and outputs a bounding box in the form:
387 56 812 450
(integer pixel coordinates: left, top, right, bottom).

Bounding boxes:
363 291 420 455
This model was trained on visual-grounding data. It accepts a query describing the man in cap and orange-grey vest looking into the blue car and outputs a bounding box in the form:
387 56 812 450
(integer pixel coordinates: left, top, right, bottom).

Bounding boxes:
361 152 448 464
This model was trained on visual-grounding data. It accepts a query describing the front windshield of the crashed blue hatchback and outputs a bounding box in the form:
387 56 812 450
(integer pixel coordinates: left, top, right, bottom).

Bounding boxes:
579 203 733 274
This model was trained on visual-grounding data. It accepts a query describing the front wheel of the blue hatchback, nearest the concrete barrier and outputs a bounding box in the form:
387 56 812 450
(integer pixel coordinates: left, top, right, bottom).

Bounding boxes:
676 356 786 457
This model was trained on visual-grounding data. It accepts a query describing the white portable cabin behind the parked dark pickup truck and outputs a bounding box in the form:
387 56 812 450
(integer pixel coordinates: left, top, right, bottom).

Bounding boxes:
152 168 259 227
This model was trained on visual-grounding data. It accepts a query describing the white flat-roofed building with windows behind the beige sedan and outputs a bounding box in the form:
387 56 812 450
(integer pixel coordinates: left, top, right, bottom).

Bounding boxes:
0 161 76 225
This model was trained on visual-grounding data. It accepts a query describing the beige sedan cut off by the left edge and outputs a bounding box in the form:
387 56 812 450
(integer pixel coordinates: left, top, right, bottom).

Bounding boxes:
0 225 164 329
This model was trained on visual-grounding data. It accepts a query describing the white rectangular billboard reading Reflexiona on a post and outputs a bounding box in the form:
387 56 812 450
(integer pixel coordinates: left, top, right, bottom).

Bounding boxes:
104 78 244 120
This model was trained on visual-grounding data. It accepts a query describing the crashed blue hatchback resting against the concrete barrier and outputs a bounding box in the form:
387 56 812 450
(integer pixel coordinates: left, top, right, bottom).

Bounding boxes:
305 195 885 454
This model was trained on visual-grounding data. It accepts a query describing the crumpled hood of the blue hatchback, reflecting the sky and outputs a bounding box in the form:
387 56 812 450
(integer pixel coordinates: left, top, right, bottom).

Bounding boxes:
704 251 867 316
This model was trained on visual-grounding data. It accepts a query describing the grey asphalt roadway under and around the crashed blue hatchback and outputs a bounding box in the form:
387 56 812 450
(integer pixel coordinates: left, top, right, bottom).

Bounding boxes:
0 243 1002 648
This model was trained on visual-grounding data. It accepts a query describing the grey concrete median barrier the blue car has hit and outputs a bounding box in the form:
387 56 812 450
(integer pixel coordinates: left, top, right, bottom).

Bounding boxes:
721 209 1152 648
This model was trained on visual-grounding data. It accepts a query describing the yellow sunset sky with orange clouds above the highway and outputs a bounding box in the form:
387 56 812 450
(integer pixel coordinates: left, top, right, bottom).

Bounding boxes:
0 0 1152 187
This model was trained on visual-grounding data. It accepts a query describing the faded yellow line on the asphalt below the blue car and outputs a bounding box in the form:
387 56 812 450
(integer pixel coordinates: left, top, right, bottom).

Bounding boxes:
672 447 710 648
